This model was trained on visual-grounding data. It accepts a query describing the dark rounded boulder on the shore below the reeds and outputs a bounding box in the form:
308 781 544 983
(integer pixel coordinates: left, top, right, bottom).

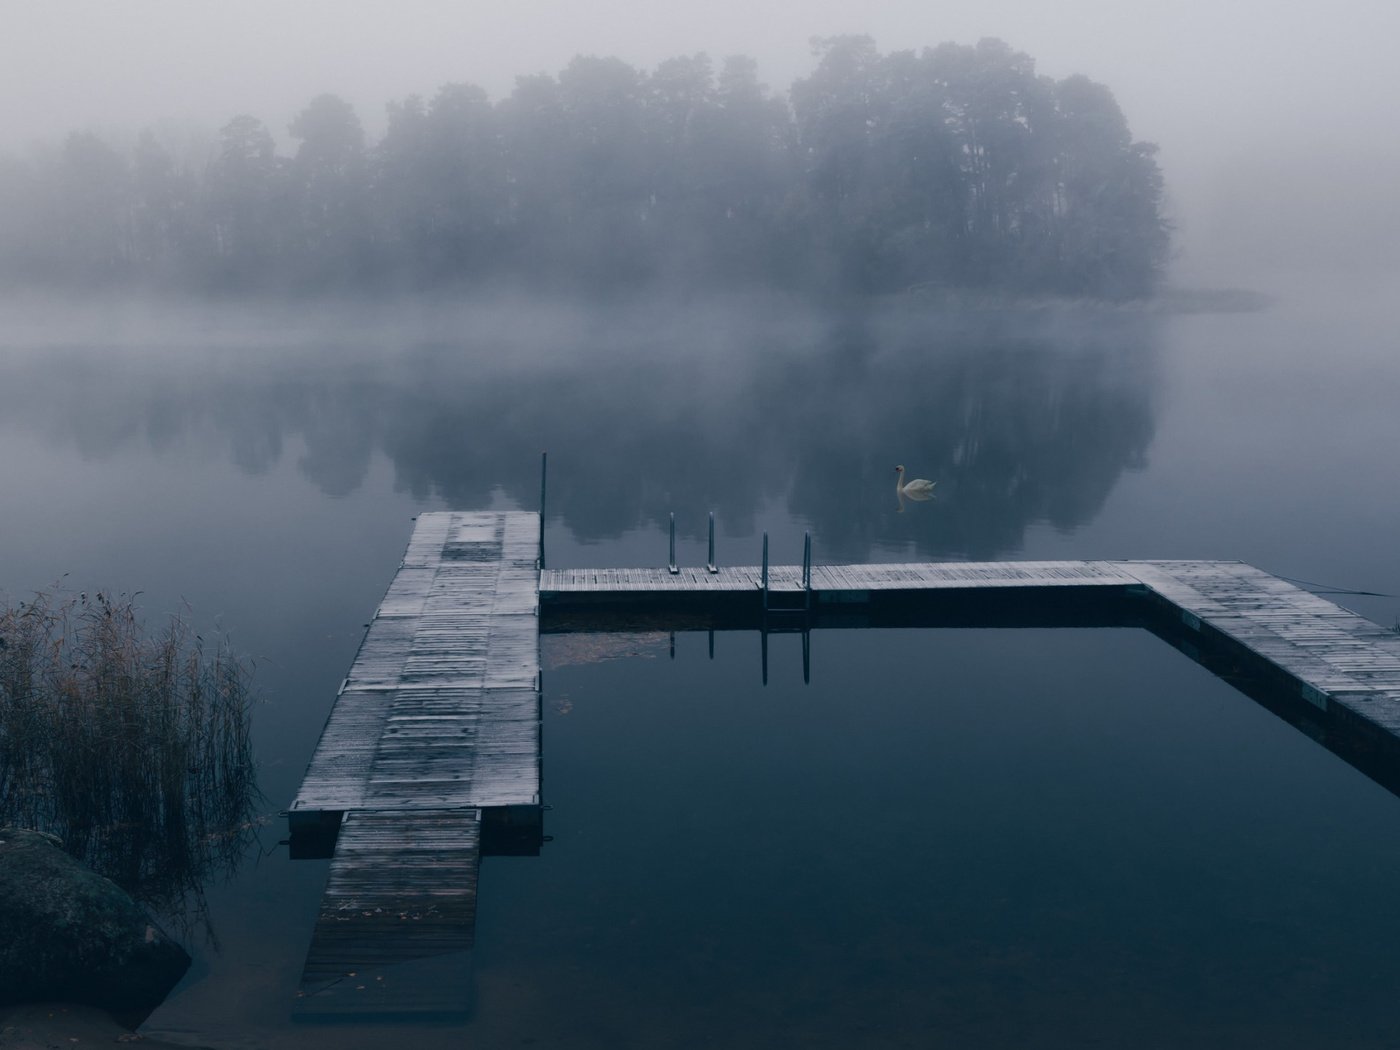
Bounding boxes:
0 827 189 1028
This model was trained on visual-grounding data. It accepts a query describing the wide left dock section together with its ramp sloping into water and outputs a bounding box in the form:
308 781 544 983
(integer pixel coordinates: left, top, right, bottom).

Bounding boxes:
288 512 540 1016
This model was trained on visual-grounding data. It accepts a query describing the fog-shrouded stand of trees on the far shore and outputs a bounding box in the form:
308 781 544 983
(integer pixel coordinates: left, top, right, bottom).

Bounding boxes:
0 36 1170 300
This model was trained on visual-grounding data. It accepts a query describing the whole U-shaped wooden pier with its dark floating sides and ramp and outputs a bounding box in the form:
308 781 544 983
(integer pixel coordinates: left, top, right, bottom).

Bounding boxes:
288 512 1400 1016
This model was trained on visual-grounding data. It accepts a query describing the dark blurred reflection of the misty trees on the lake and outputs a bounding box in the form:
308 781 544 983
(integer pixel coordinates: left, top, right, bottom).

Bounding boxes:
0 292 1162 561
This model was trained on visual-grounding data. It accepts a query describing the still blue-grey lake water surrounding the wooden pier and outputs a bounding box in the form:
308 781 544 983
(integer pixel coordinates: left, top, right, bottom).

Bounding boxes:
0 290 1400 1047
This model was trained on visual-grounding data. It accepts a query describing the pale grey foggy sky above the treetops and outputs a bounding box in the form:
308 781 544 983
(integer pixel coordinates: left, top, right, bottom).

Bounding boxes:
0 0 1400 280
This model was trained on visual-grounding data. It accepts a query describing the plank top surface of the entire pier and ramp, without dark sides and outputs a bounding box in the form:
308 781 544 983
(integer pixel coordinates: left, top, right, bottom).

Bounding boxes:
291 512 1400 1016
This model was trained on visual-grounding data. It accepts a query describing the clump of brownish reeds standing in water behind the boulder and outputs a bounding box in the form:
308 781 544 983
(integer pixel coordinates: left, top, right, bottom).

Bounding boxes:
0 592 262 937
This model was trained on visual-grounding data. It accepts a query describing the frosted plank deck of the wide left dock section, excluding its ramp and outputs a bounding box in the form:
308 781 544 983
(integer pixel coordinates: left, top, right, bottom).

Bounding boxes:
293 512 539 813
